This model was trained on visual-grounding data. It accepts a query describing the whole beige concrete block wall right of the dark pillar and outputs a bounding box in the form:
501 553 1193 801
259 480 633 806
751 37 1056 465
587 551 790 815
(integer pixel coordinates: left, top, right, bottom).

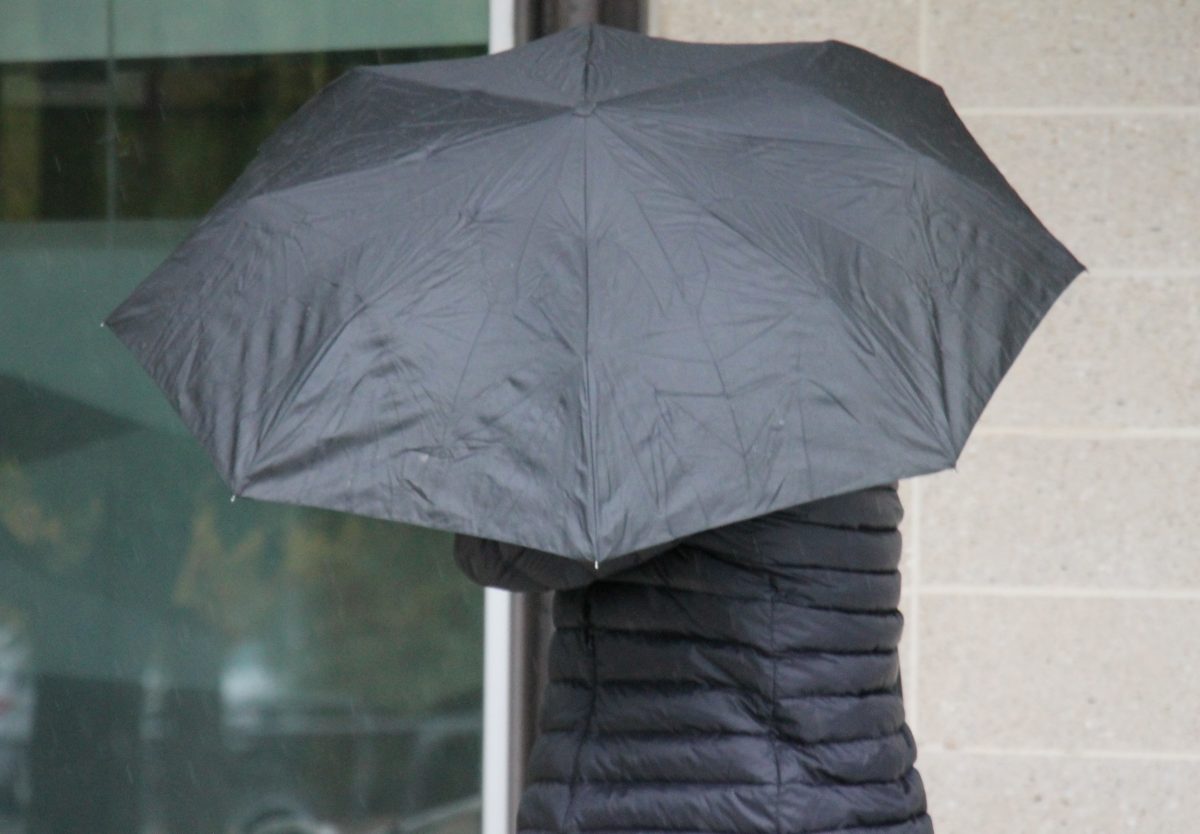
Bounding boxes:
649 0 1200 834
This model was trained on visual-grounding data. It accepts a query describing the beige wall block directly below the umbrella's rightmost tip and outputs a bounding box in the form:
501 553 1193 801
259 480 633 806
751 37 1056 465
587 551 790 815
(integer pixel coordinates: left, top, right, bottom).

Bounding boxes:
978 270 1200 428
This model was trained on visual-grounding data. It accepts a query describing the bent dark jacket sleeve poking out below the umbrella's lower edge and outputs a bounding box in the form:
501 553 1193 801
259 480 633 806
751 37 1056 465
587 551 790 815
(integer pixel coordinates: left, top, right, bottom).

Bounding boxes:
454 533 680 592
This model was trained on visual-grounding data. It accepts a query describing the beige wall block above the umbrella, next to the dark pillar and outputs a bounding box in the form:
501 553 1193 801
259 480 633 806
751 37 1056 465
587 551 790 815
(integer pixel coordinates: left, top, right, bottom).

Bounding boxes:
648 0 917 71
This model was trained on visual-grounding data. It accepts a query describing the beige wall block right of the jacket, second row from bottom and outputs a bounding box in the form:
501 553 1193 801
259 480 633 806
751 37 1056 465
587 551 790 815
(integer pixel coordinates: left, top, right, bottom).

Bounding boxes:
917 594 1200 756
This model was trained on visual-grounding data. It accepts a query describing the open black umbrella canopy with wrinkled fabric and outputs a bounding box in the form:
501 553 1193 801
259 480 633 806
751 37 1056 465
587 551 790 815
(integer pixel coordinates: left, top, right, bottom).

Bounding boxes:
106 24 1084 563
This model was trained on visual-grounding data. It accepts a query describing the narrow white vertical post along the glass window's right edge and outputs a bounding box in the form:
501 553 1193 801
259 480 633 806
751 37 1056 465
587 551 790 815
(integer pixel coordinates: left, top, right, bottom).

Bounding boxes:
480 8 516 834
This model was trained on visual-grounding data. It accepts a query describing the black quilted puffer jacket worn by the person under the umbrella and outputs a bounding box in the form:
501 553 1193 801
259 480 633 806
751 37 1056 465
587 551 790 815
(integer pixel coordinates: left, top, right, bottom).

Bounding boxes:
455 484 934 834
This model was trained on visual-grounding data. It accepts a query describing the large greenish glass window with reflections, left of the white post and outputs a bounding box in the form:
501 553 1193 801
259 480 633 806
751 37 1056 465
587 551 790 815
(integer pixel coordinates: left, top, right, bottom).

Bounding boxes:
0 0 487 834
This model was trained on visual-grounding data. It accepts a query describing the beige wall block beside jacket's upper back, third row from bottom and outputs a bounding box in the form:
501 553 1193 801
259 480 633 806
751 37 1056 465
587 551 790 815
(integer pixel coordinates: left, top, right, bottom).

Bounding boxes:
919 433 1200 593
